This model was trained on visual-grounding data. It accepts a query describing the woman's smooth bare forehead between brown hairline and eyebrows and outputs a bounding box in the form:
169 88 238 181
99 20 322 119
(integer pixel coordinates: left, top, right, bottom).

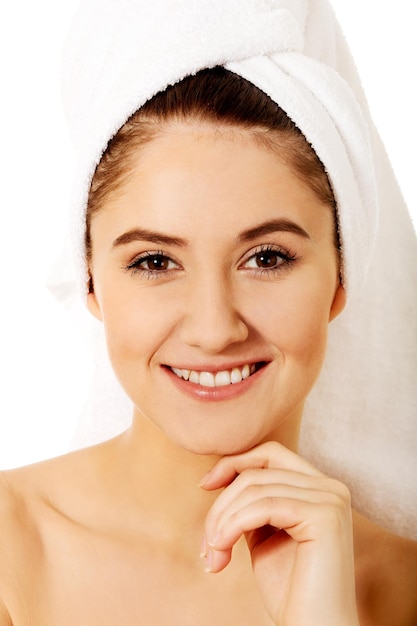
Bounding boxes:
92 123 331 246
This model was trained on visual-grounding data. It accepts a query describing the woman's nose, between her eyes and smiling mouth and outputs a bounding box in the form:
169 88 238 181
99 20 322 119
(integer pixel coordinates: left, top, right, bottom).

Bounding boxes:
181 272 249 354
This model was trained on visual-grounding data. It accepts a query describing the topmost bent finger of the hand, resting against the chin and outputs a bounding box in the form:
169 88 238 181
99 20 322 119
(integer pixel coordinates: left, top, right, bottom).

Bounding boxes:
200 441 323 490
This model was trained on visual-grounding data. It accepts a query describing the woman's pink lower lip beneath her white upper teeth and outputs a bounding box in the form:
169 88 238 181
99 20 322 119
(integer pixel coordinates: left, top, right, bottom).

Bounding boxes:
162 365 268 402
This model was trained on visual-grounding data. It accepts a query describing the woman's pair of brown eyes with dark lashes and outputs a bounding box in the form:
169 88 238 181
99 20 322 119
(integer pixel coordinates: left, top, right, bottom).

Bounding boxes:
123 244 301 279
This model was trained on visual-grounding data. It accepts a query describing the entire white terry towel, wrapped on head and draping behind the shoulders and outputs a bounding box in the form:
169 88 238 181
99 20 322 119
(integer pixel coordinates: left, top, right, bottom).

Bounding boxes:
58 0 417 536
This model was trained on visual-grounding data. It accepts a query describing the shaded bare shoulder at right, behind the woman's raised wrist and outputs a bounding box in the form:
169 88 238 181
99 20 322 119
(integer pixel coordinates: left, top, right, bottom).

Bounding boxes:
355 515 417 626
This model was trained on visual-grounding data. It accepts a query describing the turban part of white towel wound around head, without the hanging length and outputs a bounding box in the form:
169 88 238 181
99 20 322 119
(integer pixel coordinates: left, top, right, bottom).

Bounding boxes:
64 0 377 290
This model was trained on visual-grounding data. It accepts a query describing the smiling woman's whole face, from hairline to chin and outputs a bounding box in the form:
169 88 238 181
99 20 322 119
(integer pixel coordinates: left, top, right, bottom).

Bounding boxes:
88 123 344 454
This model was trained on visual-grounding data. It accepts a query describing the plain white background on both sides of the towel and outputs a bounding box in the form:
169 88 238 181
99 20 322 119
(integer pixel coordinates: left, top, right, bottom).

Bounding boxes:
0 0 417 468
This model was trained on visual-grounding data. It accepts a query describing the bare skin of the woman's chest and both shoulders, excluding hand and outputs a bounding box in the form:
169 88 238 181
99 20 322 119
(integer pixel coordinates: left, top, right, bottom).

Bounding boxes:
0 428 417 626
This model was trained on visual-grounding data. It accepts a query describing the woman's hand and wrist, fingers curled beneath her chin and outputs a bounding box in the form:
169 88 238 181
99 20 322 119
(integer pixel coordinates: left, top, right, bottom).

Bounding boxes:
201 442 359 626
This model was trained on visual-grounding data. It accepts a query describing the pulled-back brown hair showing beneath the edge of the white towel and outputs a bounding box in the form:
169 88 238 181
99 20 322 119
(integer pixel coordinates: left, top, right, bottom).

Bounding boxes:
85 66 338 261
